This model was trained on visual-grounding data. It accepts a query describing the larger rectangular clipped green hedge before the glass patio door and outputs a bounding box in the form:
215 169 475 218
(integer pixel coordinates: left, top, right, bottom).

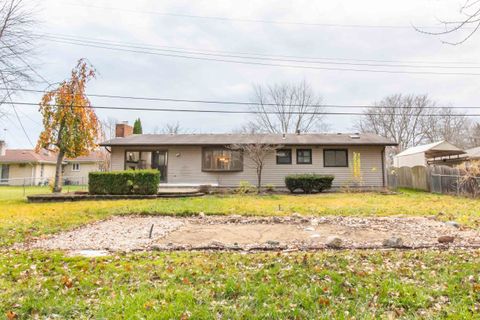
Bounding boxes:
88 170 160 195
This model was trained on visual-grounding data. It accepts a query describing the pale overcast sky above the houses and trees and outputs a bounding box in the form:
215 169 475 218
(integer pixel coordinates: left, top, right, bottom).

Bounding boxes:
0 0 480 148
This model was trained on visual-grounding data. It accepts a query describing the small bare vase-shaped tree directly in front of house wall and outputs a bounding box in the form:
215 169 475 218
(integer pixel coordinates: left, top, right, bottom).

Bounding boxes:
229 141 281 191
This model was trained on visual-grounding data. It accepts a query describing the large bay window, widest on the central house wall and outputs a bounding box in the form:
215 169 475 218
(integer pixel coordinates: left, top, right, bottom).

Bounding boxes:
202 148 243 171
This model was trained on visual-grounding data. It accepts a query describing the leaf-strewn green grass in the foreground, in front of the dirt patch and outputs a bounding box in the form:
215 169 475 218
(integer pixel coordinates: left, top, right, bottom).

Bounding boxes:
0 250 480 319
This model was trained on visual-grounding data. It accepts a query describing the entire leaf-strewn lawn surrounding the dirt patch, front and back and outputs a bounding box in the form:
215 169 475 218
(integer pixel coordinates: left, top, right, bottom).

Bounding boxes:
0 187 480 319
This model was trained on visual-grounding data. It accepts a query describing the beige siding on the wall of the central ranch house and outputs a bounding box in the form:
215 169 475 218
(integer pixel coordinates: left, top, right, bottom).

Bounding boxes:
111 146 383 187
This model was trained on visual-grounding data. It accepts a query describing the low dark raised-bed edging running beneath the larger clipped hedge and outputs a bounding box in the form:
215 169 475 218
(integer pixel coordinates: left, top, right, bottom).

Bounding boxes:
27 192 205 203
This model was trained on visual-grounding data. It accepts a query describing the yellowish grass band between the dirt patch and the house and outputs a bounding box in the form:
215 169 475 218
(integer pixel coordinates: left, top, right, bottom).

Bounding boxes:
0 187 480 246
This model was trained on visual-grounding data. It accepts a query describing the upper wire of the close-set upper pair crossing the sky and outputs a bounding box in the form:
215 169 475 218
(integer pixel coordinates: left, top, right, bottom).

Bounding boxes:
37 32 480 66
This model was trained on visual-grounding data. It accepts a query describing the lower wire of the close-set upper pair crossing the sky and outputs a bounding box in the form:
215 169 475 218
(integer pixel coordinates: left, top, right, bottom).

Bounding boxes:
39 35 480 69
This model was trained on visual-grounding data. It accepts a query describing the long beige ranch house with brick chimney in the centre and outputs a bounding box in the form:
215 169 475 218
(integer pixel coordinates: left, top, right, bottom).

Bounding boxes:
100 123 396 187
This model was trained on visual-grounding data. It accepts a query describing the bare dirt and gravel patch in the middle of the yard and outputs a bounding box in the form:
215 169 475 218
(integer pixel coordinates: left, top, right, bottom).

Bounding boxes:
17 216 480 251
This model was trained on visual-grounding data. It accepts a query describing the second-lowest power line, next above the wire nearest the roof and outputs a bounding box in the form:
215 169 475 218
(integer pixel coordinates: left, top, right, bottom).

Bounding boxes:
0 88 480 109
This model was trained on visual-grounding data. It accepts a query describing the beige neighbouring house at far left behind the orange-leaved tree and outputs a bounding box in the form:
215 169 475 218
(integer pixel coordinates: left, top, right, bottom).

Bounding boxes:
0 141 104 185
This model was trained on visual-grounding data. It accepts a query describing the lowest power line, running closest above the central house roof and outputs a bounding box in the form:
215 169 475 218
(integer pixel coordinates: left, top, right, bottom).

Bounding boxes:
12 102 480 117
